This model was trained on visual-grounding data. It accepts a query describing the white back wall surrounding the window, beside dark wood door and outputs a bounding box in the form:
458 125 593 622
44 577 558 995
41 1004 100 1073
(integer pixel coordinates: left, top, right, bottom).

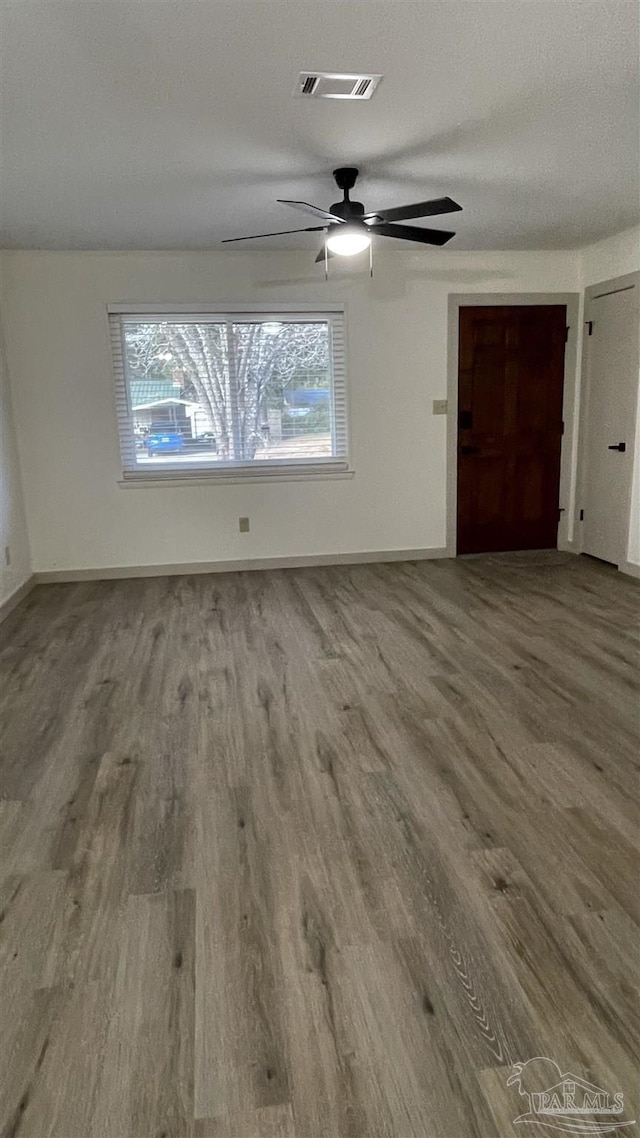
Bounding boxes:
3 250 580 571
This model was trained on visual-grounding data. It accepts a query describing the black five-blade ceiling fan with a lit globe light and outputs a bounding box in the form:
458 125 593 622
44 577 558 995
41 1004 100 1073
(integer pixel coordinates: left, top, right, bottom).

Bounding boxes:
222 166 462 262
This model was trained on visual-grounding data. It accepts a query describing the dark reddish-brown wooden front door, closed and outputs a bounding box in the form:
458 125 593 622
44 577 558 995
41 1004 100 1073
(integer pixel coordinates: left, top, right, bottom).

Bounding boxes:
458 305 566 553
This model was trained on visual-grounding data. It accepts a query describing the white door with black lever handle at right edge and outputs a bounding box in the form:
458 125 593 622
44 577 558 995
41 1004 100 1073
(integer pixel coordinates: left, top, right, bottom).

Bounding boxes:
582 273 640 566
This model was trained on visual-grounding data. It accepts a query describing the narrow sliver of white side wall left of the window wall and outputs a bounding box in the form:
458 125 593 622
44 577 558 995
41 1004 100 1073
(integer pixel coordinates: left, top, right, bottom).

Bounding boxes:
0 302 31 604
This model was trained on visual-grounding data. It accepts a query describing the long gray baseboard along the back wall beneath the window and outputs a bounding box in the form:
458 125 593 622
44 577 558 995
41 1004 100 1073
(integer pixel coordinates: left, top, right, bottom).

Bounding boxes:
34 547 449 585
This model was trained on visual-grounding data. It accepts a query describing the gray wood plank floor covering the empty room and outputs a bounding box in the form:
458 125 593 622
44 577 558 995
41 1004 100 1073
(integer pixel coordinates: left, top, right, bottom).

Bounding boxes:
0 554 640 1138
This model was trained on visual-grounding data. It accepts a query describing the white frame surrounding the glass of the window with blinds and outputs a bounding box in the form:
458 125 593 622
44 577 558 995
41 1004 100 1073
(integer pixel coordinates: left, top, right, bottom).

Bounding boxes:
107 303 353 486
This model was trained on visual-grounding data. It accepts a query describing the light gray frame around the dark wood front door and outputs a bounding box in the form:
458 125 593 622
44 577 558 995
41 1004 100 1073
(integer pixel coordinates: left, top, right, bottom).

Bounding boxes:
446 292 580 558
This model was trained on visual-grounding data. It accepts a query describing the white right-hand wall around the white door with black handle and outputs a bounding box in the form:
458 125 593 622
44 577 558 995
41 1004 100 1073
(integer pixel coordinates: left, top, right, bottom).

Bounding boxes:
580 226 640 576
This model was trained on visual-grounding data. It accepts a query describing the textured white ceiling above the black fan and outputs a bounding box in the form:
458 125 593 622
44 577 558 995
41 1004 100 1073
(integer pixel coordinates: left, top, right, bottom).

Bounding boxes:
1 0 639 249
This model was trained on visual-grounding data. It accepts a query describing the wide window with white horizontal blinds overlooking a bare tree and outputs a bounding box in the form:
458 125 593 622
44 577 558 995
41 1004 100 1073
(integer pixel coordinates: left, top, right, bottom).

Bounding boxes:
109 310 347 480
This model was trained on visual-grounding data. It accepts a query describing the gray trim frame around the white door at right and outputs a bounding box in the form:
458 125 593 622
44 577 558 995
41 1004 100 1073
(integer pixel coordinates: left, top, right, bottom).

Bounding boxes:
575 271 640 577
